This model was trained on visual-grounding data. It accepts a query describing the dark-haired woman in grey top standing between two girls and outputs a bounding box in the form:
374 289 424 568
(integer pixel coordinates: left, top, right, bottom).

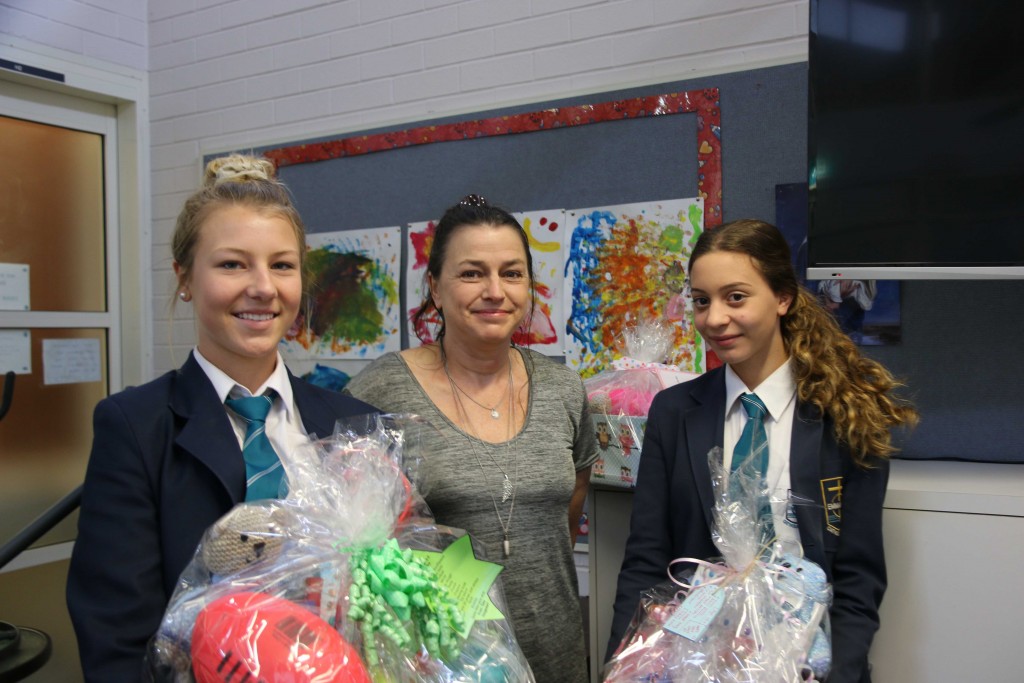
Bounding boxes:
346 195 597 683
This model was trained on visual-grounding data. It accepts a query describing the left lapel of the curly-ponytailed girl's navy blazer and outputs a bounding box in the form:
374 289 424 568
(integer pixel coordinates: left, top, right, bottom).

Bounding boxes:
683 372 725 528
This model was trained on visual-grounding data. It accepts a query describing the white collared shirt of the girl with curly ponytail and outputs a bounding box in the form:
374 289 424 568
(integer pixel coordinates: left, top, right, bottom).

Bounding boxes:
723 360 800 542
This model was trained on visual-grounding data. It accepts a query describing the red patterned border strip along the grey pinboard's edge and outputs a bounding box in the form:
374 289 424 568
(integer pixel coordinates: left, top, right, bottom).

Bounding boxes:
263 88 722 228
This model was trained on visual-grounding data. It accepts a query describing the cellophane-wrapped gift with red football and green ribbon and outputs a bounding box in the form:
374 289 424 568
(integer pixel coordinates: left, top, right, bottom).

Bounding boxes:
146 416 534 683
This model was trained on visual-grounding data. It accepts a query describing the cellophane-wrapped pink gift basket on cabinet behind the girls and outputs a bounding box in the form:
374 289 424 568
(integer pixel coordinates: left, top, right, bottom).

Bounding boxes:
584 321 697 488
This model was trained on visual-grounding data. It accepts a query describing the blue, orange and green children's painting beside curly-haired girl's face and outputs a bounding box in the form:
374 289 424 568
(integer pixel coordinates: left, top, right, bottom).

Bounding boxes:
563 198 705 378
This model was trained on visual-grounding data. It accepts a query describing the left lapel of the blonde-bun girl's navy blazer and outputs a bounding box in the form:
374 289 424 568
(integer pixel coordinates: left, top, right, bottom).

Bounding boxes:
171 354 246 503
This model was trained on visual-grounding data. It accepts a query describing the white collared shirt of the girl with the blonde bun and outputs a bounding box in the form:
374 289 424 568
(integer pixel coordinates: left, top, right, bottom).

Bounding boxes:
193 348 311 458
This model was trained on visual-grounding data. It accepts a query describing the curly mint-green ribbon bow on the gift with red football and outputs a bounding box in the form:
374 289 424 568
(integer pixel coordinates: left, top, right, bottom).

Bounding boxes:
348 539 463 666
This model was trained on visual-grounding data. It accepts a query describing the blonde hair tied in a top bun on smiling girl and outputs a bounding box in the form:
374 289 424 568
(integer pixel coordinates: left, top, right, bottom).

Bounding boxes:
171 155 307 286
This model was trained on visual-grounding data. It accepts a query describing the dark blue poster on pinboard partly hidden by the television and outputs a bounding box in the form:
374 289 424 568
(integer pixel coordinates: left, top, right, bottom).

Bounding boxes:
775 182 902 346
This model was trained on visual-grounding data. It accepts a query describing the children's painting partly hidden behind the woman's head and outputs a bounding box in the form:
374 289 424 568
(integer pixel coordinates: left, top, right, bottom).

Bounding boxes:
406 210 565 355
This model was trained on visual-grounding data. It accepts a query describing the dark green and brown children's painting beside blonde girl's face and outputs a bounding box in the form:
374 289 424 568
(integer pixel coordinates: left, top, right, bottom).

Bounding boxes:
282 227 401 359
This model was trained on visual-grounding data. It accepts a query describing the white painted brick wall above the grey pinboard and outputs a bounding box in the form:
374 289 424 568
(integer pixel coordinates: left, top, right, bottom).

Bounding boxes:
0 0 808 373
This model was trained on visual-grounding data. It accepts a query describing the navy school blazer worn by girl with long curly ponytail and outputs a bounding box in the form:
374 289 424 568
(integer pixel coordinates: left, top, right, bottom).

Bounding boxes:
606 368 889 683
